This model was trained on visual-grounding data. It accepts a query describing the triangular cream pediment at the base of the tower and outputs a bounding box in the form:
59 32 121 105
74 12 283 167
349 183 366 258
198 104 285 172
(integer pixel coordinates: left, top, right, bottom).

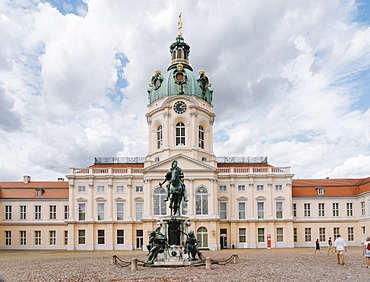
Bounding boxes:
143 154 217 173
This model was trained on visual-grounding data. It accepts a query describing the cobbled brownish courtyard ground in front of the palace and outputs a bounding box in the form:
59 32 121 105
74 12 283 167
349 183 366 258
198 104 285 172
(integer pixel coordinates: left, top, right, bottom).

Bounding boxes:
0 247 370 282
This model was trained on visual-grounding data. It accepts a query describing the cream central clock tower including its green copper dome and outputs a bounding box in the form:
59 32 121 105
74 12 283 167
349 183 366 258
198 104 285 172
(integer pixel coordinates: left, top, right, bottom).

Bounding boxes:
146 33 215 165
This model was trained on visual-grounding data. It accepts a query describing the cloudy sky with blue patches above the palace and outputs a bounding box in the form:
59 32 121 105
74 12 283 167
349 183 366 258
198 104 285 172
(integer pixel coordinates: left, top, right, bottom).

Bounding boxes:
0 0 370 181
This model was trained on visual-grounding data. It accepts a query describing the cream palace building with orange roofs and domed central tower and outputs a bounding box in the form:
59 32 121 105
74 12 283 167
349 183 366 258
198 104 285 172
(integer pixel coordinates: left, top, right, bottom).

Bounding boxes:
0 34 370 250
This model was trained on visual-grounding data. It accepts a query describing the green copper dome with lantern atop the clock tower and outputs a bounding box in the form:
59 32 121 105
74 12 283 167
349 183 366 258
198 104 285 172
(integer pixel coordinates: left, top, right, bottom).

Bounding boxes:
148 36 213 104
